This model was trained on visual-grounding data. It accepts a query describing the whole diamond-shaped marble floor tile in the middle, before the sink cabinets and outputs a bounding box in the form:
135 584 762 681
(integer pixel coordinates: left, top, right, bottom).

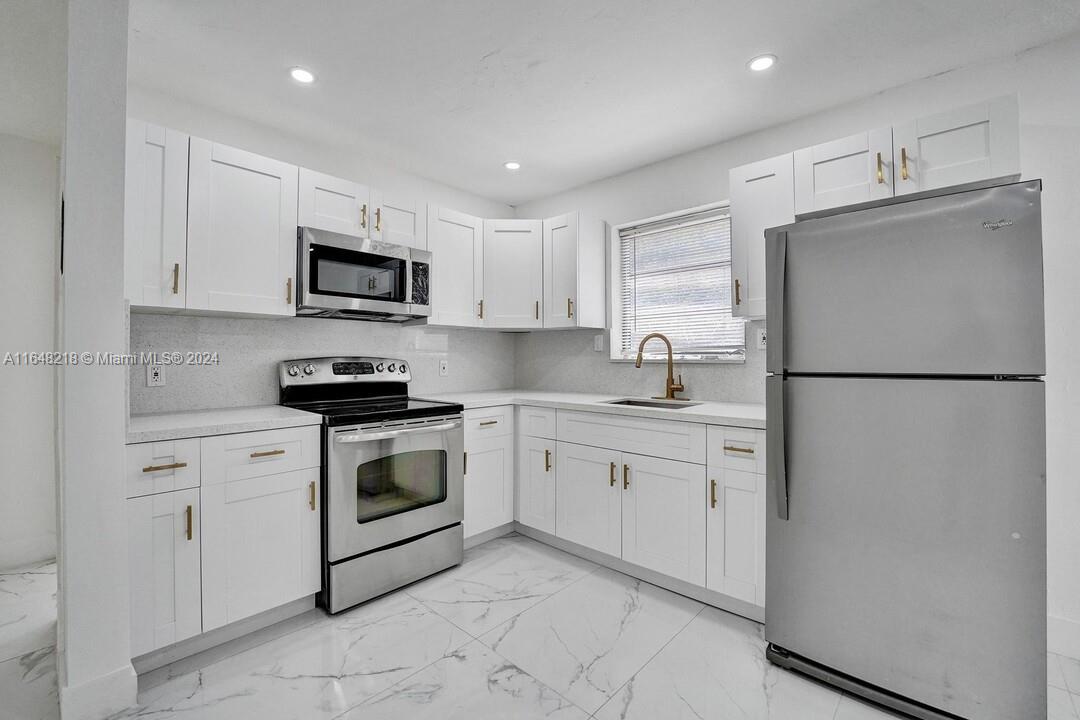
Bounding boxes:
481 568 704 712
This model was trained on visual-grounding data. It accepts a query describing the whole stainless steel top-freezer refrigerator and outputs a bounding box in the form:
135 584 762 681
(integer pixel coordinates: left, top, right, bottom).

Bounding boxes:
765 180 1047 720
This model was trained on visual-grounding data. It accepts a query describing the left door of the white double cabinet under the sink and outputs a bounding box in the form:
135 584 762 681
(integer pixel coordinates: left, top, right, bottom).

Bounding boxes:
555 443 623 557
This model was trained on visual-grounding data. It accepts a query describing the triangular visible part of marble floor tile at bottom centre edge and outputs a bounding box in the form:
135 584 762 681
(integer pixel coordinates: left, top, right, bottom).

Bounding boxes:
342 642 589 720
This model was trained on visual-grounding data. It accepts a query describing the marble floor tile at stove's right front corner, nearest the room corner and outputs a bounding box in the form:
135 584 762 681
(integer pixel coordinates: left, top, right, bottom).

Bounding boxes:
406 535 597 637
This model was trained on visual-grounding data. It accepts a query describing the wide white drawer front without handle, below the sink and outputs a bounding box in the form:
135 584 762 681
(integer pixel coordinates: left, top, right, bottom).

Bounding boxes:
555 410 705 464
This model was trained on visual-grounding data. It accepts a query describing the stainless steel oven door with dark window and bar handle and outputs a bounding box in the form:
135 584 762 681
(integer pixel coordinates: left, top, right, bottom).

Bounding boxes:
326 416 464 562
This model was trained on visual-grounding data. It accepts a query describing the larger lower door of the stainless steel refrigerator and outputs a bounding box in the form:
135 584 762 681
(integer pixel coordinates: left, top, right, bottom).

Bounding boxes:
765 378 1047 720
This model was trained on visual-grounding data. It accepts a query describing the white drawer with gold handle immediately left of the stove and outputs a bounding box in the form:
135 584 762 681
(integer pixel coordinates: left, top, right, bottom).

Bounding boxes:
202 425 322 485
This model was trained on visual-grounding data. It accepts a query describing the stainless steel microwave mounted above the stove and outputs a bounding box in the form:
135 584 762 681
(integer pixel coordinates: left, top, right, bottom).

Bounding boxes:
296 228 431 323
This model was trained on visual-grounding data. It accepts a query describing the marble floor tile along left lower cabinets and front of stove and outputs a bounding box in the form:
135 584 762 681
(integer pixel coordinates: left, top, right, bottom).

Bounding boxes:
111 594 472 720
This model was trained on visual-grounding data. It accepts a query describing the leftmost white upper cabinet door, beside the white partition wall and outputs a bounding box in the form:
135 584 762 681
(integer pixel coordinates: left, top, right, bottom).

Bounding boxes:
124 119 188 308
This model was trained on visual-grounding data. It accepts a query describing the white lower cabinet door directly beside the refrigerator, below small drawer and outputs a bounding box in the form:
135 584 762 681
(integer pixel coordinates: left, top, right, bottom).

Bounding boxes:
705 465 765 608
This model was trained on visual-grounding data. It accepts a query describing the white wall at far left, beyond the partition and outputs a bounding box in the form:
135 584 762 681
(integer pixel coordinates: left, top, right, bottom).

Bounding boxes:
0 135 59 569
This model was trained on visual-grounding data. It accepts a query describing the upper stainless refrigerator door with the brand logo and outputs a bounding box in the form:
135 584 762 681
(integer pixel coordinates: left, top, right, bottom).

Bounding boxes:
766 180 1045 376
